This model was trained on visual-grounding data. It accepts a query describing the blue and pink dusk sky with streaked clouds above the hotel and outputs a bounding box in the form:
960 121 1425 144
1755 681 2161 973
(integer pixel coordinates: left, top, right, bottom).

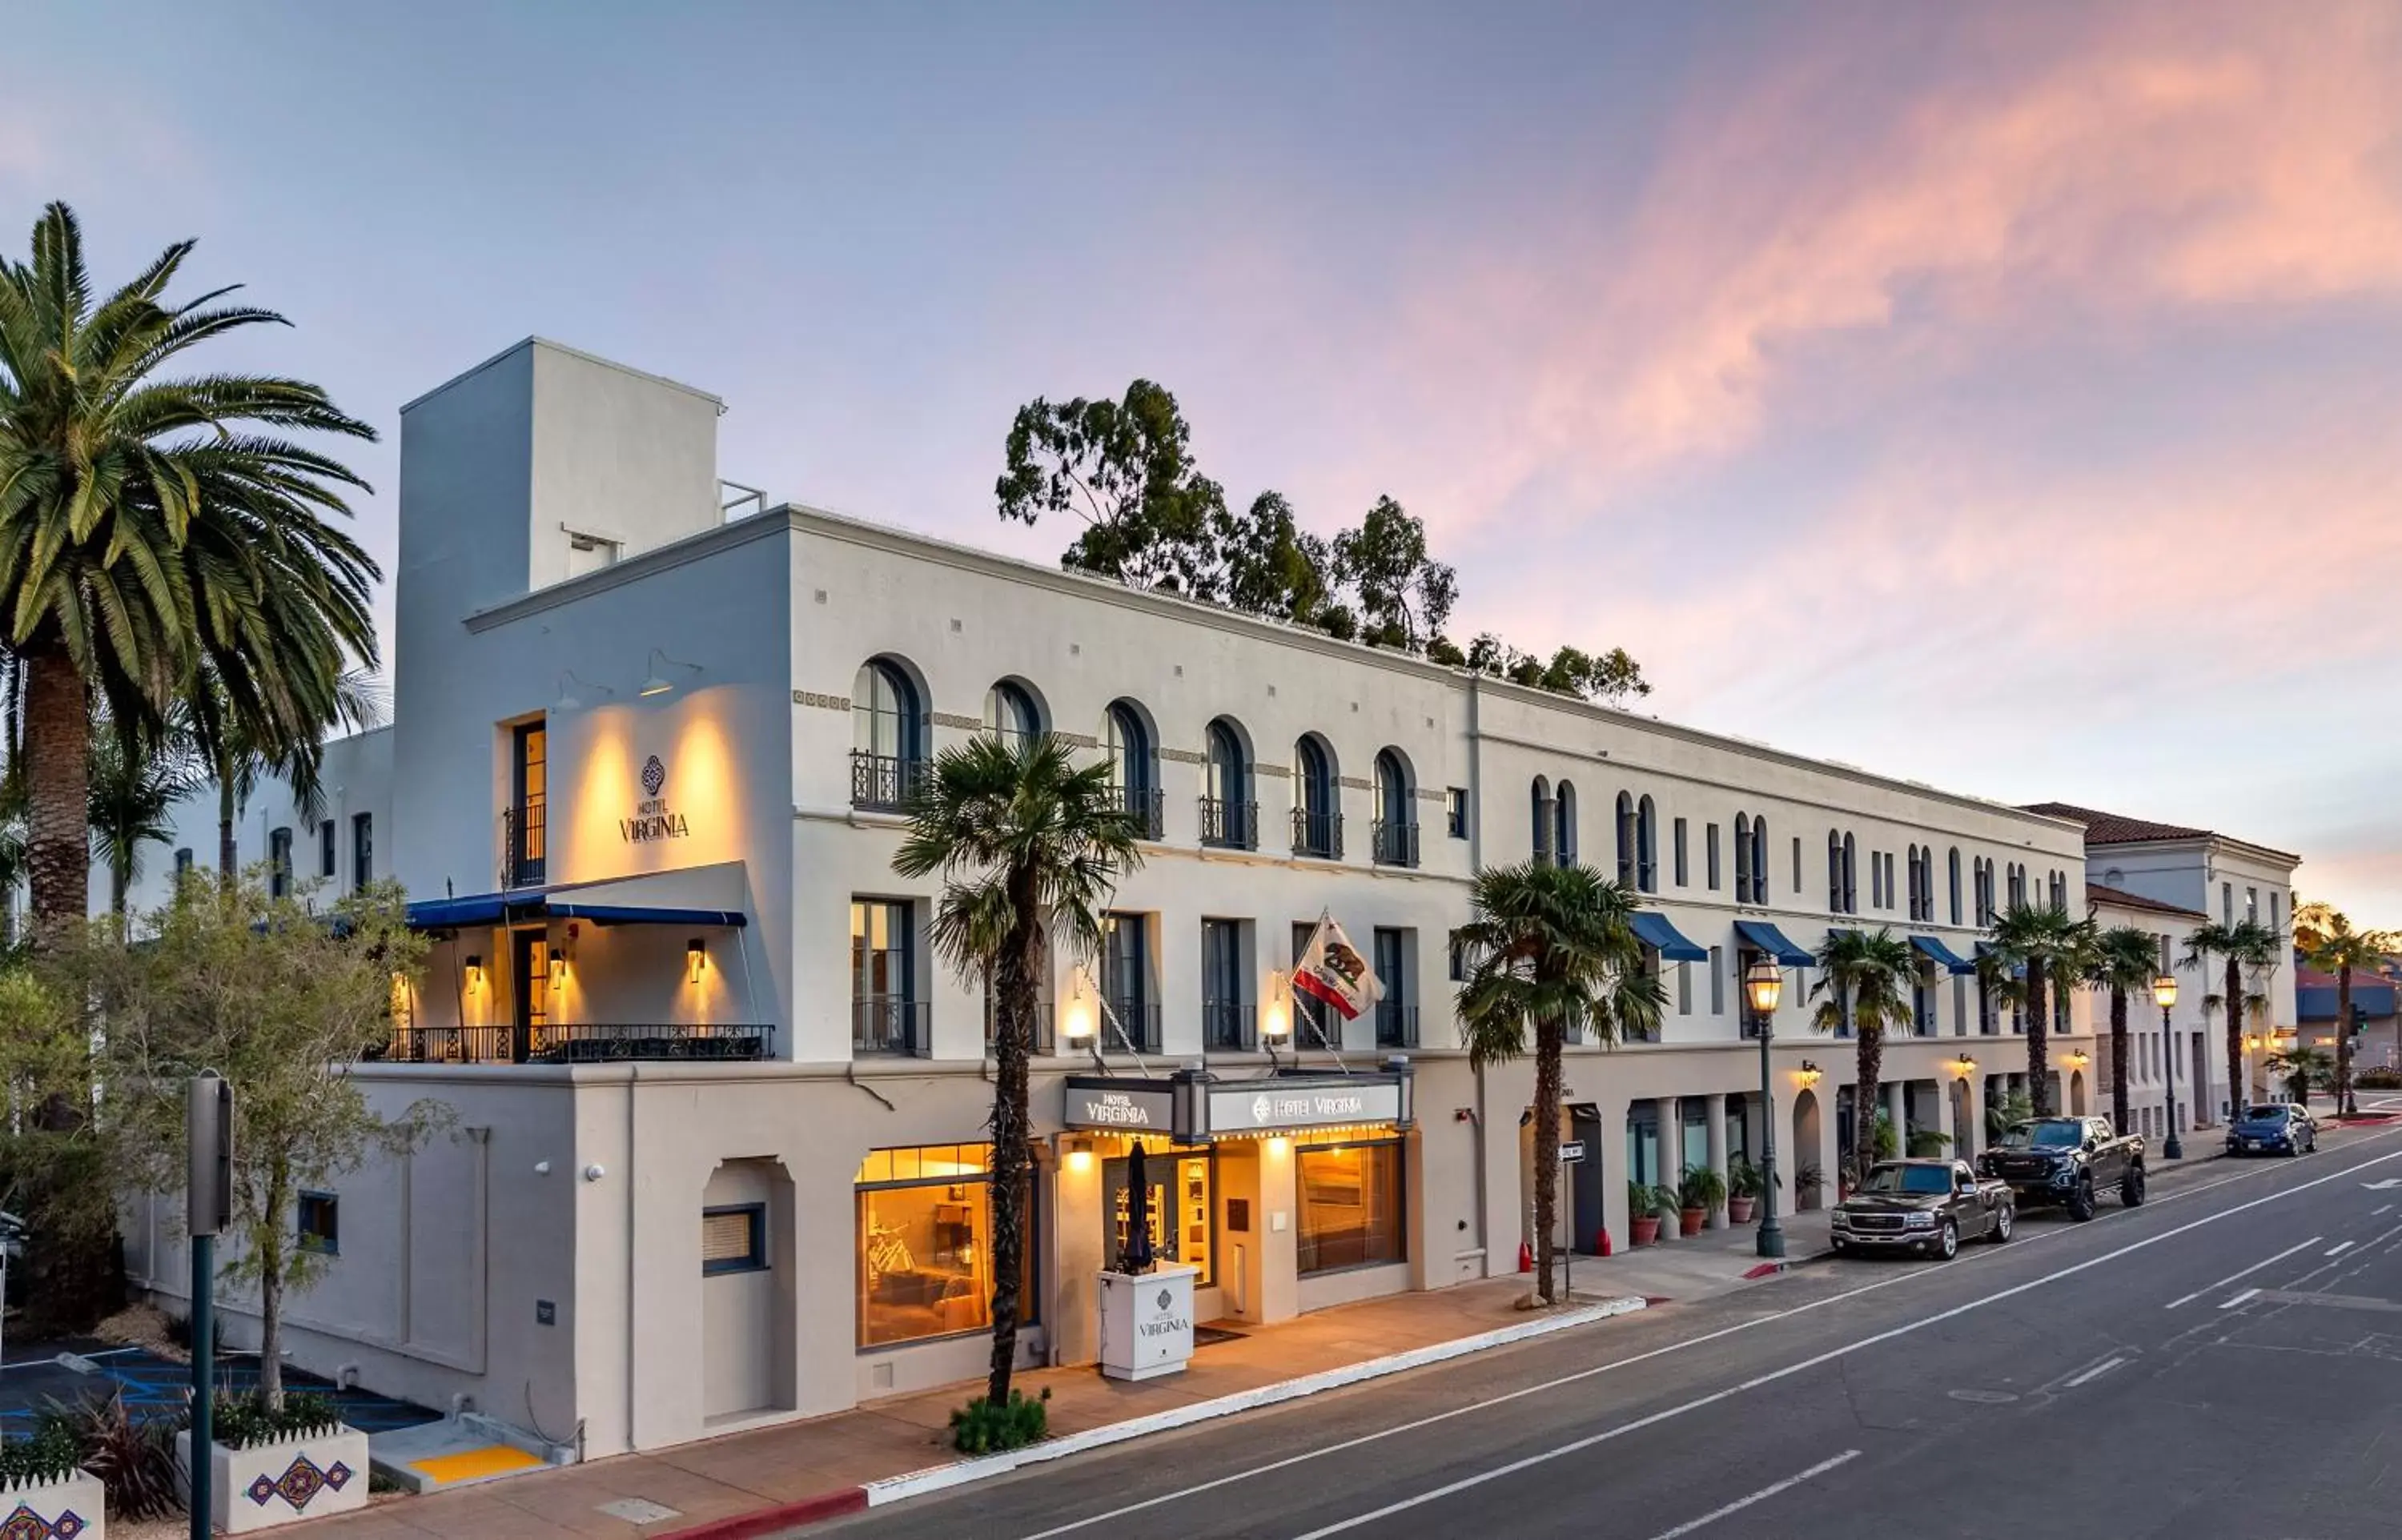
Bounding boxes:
14 0 2402 925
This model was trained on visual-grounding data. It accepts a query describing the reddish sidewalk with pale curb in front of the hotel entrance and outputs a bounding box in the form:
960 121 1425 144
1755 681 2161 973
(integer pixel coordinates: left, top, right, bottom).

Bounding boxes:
281 1271 1641 1540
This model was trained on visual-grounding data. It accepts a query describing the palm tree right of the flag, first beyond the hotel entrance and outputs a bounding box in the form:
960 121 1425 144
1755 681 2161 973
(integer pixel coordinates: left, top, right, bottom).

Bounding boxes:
1458 863 1667 1305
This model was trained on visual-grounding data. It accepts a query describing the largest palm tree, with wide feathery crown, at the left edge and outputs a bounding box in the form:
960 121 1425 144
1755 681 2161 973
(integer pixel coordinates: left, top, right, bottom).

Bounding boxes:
0 204 380 925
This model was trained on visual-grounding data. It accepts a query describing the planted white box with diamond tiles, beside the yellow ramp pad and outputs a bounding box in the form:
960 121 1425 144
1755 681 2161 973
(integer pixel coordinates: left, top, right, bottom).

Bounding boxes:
175 1391 368 1535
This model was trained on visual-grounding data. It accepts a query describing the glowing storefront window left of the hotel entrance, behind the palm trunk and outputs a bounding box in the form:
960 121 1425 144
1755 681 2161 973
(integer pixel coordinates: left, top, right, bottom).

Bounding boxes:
858 1144 1035 1348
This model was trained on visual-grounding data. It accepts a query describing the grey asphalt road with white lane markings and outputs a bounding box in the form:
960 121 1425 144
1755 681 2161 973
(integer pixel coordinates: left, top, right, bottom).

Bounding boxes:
814 1125 2402 1540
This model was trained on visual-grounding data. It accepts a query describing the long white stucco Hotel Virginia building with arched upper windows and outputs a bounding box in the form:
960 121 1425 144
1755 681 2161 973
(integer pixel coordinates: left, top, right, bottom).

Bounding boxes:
117 341 2104 1454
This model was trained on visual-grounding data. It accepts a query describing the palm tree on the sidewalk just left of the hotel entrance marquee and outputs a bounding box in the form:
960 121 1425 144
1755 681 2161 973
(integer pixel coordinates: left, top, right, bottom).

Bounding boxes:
894 732 1143 1408
